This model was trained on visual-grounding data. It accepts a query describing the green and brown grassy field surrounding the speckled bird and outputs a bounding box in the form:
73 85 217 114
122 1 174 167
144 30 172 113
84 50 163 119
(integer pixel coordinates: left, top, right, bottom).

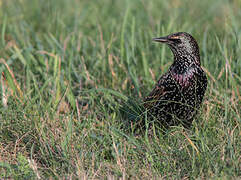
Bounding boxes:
0 0 241 179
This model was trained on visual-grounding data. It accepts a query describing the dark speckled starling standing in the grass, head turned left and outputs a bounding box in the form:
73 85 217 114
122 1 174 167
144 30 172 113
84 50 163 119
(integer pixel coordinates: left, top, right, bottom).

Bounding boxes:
144 32 207 127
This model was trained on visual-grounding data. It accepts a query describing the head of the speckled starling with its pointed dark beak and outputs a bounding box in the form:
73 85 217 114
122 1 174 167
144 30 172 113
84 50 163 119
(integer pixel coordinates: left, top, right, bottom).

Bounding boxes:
153 32 200 64
